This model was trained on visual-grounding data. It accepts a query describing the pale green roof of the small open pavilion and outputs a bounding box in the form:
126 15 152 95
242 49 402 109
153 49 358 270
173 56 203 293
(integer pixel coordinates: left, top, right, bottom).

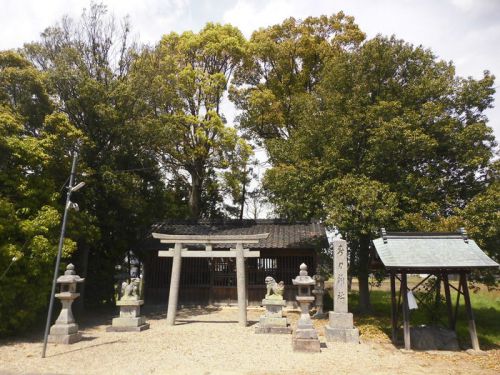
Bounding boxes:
373 230 499 269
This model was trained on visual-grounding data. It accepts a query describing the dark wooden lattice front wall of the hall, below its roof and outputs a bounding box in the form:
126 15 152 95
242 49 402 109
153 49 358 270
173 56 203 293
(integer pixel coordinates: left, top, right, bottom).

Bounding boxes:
145 249 316 305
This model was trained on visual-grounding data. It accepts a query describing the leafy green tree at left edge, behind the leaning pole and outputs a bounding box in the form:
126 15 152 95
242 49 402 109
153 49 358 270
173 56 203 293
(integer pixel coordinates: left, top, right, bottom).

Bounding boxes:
0 51 80 335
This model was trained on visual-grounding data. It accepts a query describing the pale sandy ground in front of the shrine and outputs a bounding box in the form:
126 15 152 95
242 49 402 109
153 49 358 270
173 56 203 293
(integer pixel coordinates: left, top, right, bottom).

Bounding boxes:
0 307 500 375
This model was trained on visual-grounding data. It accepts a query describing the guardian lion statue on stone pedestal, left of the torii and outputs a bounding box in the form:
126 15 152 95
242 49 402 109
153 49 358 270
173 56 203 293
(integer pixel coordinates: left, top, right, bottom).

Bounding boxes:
106 278 149 332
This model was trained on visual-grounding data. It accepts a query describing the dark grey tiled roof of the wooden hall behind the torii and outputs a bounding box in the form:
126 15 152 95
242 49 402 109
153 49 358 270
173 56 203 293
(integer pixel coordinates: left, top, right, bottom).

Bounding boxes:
151 220 328 249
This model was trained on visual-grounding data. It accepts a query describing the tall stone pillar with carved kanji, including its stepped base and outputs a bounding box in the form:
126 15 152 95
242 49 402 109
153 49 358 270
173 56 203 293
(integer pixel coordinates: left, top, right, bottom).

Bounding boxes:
325 239 359 343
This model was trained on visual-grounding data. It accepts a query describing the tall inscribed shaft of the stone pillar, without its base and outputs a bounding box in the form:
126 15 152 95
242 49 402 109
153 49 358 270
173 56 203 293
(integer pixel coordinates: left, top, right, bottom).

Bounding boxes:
333 239 348 313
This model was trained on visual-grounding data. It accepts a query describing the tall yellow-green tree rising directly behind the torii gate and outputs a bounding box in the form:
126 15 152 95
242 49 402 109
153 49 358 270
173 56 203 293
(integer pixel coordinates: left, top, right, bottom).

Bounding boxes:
131 23 248 218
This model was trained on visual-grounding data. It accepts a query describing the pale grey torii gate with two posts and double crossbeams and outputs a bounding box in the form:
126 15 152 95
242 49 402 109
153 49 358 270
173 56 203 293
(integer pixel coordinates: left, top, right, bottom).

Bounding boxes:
153 233 269 326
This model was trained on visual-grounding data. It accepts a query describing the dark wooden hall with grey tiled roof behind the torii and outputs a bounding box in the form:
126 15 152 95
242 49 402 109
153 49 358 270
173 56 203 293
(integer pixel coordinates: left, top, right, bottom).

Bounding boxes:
143 220 328 305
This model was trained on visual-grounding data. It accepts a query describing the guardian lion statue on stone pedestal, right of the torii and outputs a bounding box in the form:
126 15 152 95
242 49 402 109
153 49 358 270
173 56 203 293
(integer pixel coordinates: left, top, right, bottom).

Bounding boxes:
255 276 292 334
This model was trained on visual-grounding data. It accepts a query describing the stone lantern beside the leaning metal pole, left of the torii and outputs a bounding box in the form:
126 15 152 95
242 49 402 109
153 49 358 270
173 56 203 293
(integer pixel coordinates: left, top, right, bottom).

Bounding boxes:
48 263 85 344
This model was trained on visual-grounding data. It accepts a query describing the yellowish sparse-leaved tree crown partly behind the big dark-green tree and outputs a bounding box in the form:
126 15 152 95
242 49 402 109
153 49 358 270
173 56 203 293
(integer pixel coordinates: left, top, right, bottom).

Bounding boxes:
231 12 365 152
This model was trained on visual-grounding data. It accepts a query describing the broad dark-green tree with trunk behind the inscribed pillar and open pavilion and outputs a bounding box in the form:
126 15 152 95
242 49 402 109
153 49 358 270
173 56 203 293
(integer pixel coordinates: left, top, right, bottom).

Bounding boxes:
232 15 495 309
